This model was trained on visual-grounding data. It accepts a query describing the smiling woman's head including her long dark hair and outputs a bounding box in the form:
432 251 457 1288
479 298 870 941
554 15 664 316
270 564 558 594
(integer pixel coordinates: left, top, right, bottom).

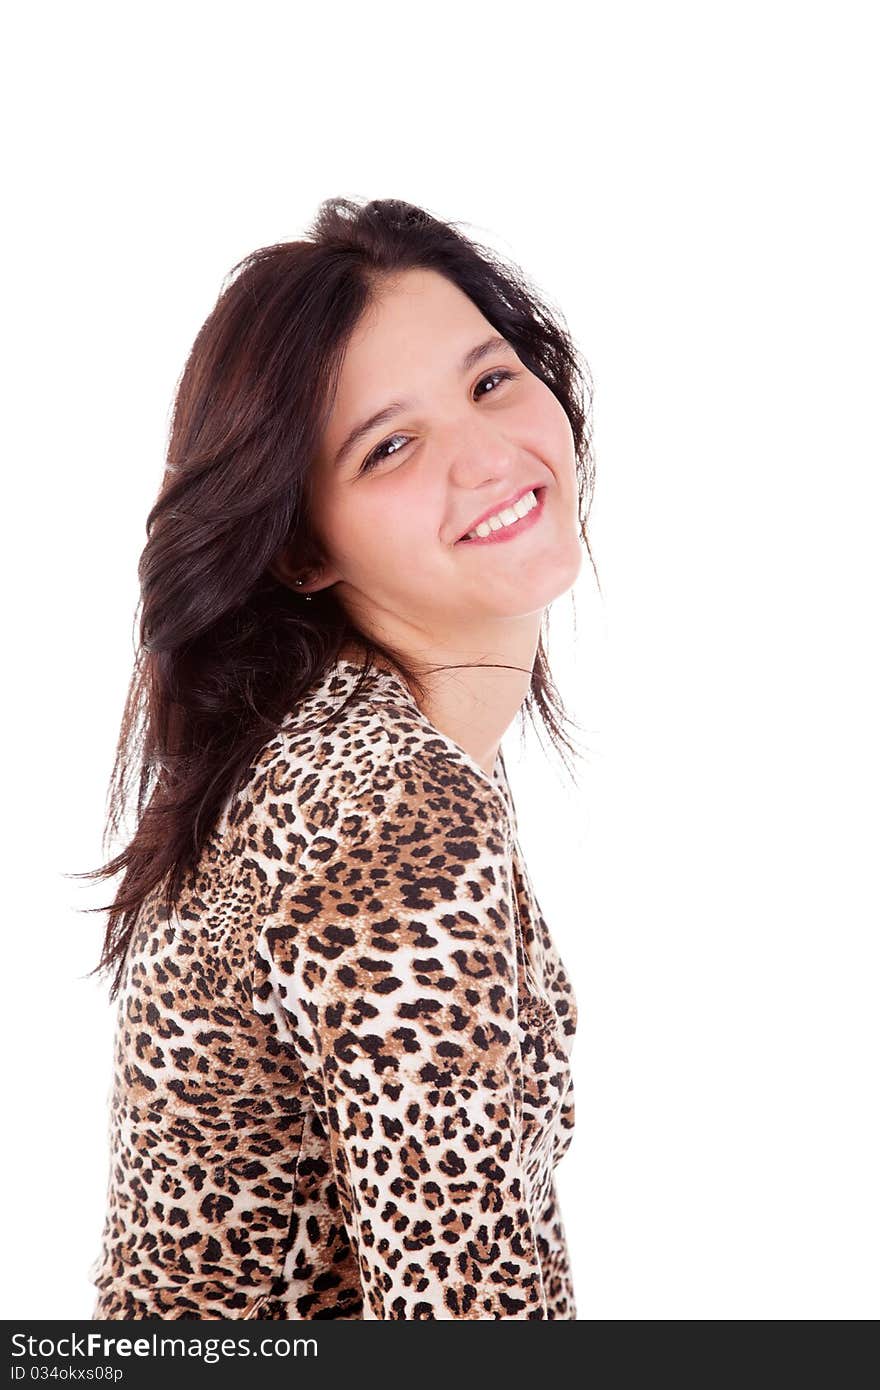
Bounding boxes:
83 199 595 992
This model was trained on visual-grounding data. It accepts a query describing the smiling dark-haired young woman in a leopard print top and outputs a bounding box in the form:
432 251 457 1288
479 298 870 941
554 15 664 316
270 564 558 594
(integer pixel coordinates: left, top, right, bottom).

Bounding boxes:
84 199 592 1319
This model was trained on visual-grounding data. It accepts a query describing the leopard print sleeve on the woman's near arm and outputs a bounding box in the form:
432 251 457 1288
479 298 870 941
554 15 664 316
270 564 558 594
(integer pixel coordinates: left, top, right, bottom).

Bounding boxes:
248 756 548 1319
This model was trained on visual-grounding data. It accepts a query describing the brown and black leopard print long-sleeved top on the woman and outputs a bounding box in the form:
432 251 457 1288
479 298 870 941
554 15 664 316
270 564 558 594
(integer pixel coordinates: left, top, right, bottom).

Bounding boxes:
89 659 577 1319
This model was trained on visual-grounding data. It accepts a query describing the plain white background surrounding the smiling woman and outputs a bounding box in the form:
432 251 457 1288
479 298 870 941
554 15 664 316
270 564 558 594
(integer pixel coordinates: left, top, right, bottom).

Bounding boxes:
0 0 880 1319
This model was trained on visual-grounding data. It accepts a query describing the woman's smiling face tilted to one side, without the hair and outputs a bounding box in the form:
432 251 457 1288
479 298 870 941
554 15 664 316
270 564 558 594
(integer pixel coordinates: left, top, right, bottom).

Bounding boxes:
300 270 582 646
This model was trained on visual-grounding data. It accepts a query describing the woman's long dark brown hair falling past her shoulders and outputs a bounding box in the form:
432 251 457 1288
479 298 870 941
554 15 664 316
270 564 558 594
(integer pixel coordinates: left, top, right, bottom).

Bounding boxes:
71 197 595 999
